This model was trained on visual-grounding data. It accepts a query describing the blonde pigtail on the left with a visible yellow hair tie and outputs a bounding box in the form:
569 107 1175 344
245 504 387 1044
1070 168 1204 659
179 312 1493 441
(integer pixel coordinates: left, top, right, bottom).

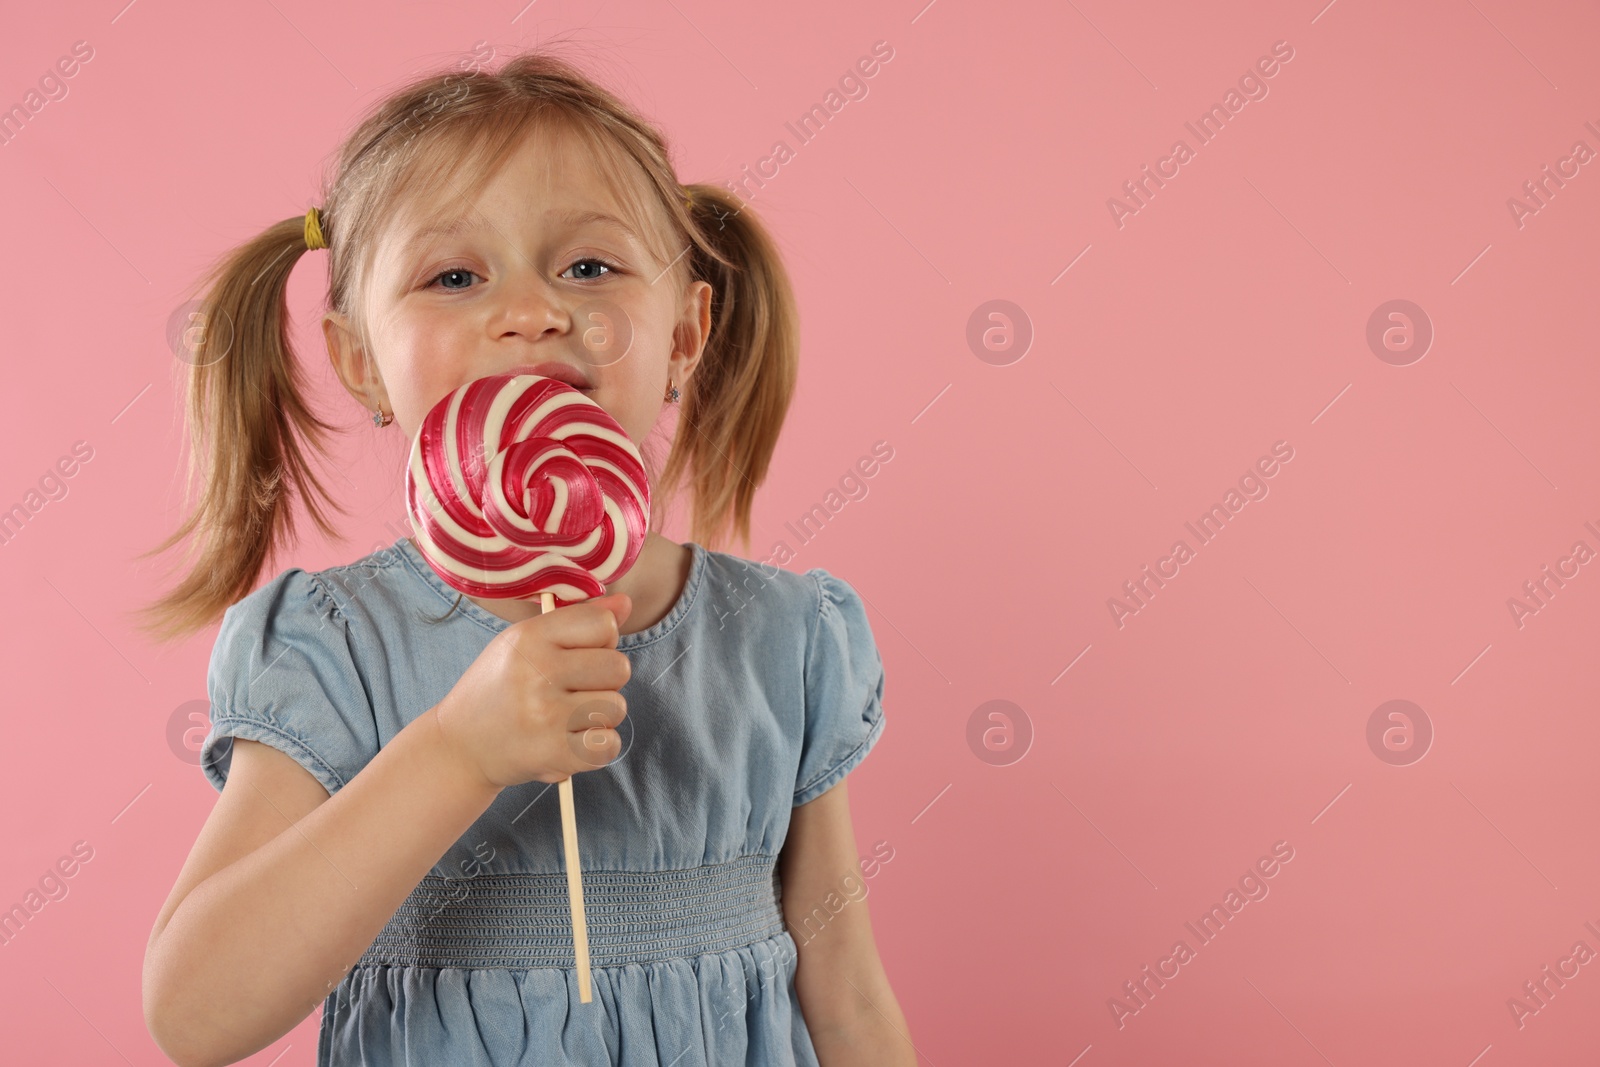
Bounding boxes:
138 216 342 640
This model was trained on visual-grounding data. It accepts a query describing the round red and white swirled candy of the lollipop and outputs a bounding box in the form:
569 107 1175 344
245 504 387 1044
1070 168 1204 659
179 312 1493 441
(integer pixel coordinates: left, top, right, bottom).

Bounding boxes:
405 374 650 605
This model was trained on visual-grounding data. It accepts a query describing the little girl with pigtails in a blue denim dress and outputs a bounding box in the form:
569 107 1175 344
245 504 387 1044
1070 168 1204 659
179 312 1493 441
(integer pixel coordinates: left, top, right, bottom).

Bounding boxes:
144 45 915 1067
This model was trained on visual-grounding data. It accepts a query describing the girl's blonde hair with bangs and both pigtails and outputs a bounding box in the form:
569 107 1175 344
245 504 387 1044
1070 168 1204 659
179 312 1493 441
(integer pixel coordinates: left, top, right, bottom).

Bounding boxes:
139 51 800 640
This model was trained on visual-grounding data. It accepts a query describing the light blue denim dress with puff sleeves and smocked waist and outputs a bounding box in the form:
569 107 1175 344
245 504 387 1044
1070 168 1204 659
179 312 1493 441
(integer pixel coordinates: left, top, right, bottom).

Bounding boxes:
202 537 883 1067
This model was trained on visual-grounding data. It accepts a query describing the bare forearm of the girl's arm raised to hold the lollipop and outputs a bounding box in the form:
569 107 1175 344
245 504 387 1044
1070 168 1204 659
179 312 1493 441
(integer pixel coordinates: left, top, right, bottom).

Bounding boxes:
150 709 498 1064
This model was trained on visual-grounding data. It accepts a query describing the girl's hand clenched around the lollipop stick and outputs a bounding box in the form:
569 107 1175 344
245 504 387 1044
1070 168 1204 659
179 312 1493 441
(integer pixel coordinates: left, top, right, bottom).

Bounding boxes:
434 593 634 789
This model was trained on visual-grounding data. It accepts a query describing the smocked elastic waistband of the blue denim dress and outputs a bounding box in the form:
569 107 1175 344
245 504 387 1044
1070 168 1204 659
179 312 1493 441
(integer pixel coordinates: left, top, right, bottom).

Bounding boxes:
357 854 784 968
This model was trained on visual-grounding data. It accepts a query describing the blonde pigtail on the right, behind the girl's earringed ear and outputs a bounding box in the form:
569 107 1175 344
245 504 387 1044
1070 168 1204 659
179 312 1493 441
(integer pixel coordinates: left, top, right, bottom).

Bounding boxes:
661 184 800 552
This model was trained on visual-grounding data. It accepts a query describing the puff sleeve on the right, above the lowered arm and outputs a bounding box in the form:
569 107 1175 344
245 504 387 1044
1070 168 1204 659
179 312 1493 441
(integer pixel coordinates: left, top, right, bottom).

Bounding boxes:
794 568 883 806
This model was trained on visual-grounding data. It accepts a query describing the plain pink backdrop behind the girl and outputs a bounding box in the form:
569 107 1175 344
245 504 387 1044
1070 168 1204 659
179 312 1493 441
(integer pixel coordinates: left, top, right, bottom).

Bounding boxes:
0 0 1600 1067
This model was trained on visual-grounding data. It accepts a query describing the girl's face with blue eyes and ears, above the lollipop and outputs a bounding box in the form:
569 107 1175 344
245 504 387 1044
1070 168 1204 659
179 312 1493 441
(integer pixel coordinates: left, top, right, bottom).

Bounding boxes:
323 126 710 443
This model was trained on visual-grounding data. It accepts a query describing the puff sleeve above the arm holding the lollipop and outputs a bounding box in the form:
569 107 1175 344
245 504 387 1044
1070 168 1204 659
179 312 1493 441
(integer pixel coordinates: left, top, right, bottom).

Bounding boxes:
200 568 379 795
